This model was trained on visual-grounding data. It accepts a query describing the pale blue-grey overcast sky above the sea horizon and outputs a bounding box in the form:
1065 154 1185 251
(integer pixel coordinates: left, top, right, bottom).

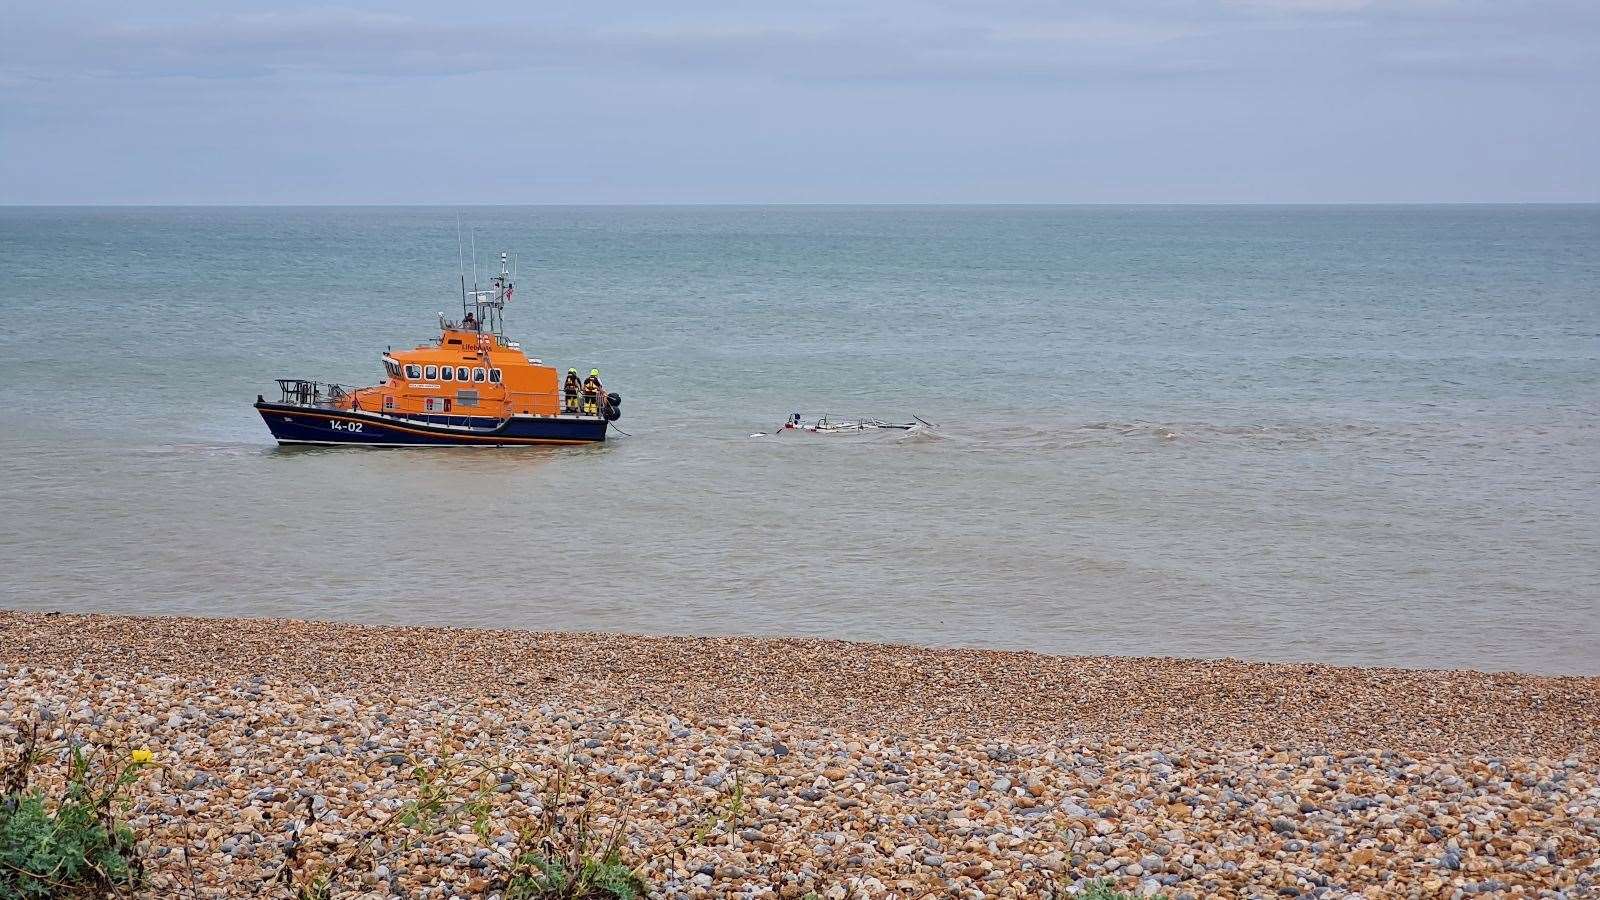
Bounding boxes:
0 0 1600 203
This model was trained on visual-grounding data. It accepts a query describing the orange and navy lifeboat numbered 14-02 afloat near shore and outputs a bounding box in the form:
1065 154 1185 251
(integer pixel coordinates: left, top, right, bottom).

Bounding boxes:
256 253 622 447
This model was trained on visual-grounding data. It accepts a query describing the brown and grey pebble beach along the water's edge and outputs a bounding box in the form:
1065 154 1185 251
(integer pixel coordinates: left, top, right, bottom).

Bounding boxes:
0 613 1600 900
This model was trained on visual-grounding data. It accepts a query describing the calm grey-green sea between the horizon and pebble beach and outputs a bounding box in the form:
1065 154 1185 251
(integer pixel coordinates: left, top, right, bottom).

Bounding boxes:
0 207 1600 674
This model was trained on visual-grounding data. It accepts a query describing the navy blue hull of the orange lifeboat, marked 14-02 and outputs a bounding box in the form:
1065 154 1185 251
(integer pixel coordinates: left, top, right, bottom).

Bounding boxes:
256 404 608 447
